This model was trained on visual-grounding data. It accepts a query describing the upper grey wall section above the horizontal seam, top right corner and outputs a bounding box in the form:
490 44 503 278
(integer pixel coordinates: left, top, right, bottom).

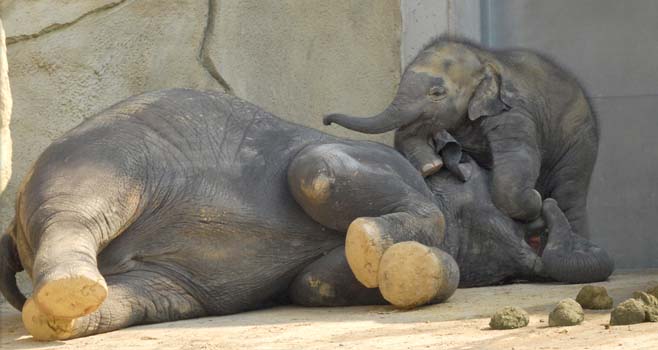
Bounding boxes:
489 0 658 96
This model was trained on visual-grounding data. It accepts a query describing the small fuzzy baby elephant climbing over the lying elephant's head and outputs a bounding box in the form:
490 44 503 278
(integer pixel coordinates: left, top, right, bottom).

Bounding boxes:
324 38 599 238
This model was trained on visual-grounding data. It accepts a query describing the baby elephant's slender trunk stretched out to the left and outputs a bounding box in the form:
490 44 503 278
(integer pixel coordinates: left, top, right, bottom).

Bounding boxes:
323 102 419 134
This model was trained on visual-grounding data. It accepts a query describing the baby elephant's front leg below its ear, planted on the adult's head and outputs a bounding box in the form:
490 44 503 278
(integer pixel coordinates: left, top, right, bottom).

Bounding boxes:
483 111 542 221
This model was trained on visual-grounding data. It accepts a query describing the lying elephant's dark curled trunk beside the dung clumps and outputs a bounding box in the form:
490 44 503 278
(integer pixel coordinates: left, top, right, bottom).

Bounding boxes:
542 199 614 283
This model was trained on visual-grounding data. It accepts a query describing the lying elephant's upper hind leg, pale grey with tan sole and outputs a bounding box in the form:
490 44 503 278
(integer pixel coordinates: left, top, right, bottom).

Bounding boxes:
16 160 142 318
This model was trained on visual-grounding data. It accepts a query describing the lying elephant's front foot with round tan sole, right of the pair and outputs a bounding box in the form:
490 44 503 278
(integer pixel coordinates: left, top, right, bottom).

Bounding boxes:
378 242 459 309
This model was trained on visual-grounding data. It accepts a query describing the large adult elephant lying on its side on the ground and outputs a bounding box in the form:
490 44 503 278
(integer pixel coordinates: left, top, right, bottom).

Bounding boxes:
0 89 612 339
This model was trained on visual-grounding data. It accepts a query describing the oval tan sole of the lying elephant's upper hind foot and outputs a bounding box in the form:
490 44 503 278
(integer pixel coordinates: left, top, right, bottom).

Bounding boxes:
34 276 107 318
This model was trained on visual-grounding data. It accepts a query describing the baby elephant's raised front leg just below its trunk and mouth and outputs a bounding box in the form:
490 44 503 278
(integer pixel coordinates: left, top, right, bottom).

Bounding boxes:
395 129 443 177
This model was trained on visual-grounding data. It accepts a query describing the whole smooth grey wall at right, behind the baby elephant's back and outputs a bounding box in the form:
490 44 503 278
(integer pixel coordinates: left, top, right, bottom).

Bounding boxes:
482 0 658 268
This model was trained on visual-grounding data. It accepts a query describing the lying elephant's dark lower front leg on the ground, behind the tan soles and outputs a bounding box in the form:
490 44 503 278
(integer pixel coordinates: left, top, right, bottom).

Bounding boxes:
288 245 386 306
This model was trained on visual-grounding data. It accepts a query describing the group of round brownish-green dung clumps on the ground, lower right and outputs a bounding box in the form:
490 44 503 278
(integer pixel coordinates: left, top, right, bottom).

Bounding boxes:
489 286 658 329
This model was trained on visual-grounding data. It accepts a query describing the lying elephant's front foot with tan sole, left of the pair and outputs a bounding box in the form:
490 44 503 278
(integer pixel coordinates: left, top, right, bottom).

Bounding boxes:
345 218 393 288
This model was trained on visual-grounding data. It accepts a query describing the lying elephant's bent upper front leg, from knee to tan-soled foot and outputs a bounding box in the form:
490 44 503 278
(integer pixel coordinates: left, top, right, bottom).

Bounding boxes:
288 144 452 306
